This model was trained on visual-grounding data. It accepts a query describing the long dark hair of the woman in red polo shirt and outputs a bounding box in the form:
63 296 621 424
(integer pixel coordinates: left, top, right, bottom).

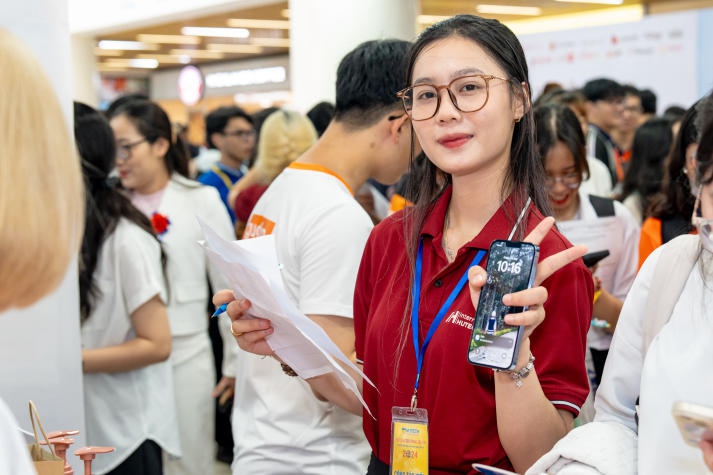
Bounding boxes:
406 15 550 263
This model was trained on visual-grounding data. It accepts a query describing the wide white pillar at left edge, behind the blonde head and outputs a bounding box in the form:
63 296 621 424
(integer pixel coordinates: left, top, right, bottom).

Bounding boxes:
0 0 86 473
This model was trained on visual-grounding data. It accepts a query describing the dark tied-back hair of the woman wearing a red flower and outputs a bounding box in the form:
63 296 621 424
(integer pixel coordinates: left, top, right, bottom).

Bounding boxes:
109 99 190 178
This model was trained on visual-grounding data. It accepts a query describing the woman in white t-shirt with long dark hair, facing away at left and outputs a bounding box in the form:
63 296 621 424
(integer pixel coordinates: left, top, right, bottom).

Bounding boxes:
74 102 180 475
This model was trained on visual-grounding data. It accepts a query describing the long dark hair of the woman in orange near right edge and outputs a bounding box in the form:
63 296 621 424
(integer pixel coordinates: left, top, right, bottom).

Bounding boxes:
648 101 700 219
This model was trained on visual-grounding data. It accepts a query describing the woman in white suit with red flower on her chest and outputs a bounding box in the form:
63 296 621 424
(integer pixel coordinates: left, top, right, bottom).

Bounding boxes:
109 100 235 475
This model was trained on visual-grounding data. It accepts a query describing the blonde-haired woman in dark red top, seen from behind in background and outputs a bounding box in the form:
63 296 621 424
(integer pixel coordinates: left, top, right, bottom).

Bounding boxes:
228 110 317 238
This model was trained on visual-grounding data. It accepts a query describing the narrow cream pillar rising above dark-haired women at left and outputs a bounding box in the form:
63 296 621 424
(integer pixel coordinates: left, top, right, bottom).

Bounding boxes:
72 34 99 108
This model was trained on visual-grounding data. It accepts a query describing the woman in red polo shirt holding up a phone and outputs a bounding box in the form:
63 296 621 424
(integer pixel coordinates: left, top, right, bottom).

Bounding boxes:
221 15 593 475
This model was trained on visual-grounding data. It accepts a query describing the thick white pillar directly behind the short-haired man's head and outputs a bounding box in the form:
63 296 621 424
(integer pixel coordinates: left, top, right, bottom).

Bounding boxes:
289 0 418 112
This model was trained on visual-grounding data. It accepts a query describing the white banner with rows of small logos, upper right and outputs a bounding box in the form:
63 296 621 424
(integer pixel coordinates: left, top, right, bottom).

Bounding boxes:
520 11 700 113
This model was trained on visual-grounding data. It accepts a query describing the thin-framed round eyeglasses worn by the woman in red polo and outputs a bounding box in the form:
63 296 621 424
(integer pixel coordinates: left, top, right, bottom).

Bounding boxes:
396 74 507 120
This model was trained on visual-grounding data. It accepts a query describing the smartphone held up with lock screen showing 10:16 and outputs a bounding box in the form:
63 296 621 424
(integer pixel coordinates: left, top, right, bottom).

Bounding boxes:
468 240 540 369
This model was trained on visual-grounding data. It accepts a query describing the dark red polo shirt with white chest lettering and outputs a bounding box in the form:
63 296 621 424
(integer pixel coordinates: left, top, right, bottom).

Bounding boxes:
354 188 593 475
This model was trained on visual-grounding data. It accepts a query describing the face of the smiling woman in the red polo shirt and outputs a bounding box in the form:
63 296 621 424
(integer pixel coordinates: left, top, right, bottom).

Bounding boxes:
411 36 523 181
